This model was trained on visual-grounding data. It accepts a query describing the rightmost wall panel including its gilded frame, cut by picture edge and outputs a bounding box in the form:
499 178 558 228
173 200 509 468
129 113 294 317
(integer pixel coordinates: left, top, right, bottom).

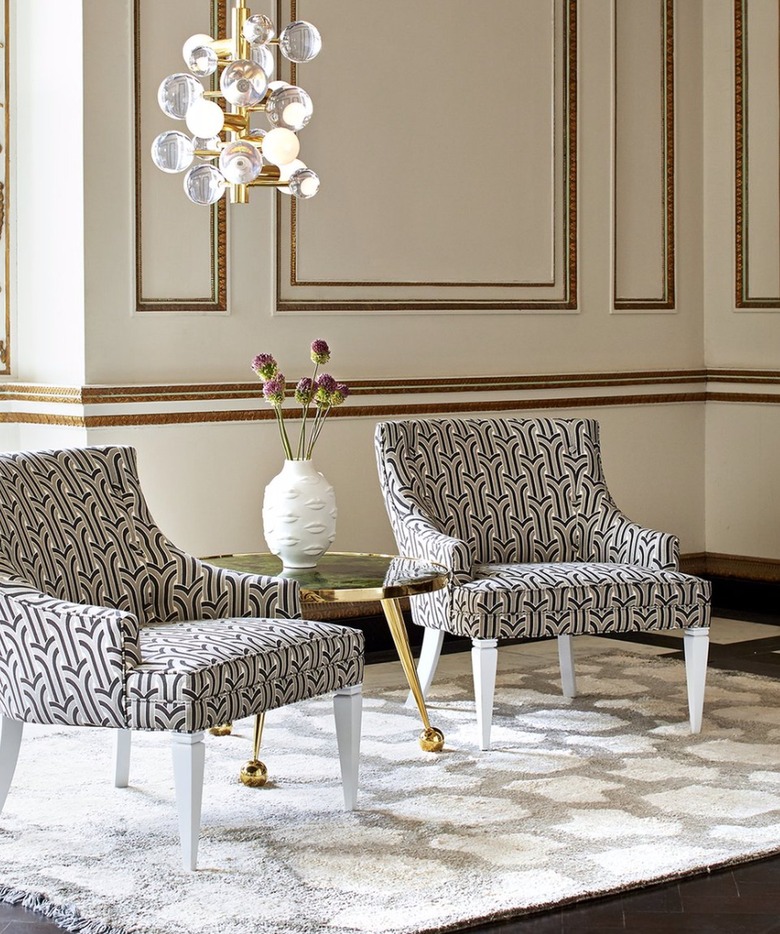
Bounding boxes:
734 0 780 309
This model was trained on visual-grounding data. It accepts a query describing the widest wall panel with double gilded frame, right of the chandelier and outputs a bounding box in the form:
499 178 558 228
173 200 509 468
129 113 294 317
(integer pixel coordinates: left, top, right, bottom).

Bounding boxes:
276 0 577 312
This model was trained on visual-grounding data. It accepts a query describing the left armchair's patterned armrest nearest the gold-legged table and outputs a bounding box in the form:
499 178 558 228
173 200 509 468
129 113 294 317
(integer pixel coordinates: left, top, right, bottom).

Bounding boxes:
157 549 301 622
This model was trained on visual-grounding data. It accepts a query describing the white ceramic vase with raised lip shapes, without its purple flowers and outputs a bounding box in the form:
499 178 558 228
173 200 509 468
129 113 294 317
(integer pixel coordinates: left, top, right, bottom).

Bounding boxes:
263 460 336 568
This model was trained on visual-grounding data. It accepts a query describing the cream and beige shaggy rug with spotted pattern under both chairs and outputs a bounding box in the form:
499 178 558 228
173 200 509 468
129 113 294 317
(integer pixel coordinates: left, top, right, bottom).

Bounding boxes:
0 643 780 934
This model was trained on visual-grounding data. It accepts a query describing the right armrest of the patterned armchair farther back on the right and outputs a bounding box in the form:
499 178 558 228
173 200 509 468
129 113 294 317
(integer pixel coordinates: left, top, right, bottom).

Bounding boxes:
588 504 680 571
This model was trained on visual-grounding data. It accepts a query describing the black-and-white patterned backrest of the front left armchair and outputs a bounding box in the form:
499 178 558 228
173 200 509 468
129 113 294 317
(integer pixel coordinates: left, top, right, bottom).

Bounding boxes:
0 446 150 621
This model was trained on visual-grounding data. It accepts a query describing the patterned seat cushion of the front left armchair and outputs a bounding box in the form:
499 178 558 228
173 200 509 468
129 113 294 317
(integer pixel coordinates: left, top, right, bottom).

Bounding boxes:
127 619 363 733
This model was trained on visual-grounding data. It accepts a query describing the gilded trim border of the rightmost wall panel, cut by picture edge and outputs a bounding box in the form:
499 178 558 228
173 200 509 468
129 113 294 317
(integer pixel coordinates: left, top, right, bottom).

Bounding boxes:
734 0 780 309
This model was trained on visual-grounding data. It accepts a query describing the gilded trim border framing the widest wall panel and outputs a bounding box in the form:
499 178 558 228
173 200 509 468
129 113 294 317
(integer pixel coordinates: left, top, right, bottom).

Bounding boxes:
276 0 578 312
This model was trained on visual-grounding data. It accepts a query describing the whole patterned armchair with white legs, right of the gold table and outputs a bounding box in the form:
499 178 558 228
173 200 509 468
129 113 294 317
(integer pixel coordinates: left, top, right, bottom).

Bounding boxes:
376 418 710 749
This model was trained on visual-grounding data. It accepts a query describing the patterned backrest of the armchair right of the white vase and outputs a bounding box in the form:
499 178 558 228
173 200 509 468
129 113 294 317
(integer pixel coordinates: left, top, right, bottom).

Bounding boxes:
376 418 609 564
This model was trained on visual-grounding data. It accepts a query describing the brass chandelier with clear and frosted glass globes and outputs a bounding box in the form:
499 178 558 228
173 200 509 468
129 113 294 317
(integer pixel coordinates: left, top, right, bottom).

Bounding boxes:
152 0 322 204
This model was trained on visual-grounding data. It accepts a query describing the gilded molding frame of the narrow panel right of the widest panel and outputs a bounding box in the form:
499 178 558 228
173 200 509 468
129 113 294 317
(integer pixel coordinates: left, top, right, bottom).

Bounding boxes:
612 0 675 311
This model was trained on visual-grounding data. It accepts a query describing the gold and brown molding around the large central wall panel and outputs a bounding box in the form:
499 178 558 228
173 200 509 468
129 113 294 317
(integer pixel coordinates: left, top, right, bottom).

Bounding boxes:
276 0 578 312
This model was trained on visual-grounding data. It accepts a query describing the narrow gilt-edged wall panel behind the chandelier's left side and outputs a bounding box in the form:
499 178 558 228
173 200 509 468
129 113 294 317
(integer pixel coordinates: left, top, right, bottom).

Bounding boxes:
134 0 227 312
